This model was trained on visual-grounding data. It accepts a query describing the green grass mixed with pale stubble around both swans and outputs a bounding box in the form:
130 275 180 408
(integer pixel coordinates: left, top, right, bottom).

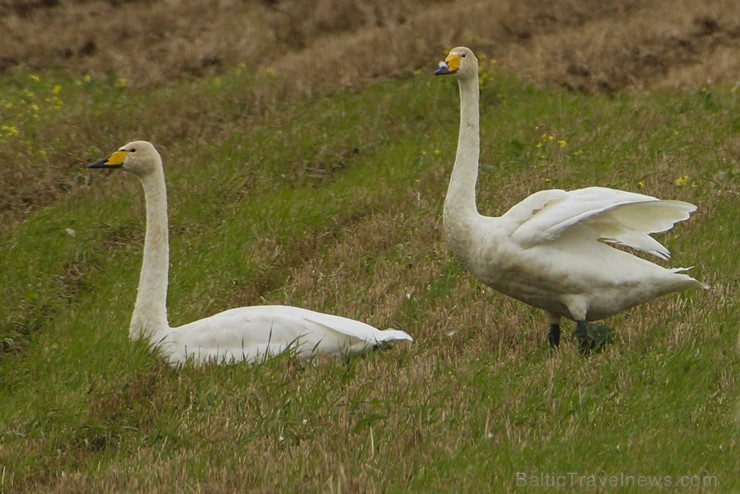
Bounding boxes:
0 66 740 492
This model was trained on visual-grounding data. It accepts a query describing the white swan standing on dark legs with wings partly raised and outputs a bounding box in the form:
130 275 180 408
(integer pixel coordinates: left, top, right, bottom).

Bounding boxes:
435 47 703 350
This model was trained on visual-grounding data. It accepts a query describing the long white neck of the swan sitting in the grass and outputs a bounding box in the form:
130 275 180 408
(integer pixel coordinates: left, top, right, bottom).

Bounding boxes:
129 166 169 340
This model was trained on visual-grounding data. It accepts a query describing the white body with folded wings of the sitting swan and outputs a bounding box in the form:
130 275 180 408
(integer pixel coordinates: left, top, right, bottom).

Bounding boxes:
165 305 413 363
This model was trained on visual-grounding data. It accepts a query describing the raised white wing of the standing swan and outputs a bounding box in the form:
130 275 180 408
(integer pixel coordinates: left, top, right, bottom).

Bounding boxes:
507 187 696 259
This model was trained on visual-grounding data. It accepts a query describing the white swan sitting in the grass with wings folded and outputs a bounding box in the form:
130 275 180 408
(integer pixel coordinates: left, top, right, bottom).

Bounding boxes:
89 141 413 365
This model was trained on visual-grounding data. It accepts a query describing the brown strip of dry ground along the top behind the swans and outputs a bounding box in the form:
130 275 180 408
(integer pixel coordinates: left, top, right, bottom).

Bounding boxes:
0 0 740 93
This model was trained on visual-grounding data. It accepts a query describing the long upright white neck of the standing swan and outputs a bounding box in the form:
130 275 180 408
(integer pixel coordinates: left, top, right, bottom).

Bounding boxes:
444 74 480 250
